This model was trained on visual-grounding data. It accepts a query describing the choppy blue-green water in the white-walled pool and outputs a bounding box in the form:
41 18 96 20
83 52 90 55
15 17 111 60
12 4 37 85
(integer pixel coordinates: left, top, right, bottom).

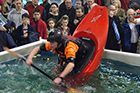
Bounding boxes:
0 57 140 93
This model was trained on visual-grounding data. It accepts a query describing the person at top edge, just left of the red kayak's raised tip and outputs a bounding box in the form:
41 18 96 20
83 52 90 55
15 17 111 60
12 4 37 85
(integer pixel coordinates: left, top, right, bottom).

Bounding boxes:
84 0 97 14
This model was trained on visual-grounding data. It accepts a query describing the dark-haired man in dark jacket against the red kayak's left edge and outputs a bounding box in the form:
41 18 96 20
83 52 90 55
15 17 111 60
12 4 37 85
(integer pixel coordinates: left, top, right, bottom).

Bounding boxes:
73 6 84 29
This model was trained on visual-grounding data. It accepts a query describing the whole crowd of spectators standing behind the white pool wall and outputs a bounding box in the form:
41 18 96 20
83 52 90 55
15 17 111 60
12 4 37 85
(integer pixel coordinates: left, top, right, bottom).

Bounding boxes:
0 0 140 53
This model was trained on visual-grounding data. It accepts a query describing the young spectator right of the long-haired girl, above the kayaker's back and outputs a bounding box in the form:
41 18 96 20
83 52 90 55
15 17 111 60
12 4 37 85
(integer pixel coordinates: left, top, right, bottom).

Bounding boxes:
57 15 70 36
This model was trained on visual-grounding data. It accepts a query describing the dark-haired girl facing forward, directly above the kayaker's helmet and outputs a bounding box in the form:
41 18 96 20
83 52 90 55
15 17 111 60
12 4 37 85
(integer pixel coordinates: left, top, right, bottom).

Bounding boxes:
47 18 56 34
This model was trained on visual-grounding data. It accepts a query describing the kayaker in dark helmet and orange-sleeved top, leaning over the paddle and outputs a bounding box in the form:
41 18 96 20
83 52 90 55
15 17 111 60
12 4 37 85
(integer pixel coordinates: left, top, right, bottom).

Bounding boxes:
26 29 92 84
